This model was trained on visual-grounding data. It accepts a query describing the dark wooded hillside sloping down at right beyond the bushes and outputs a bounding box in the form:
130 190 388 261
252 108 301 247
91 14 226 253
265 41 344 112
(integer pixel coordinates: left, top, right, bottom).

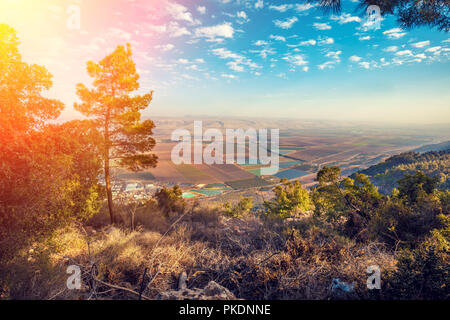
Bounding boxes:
351 150 450 194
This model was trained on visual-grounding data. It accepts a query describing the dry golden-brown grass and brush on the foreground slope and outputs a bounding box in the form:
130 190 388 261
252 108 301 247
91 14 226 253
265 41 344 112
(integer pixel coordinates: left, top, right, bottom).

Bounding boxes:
4 202 395 299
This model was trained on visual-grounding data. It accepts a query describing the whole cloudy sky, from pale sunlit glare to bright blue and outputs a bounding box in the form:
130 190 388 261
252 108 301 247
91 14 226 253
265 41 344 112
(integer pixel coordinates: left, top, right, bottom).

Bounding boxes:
0 0 450 125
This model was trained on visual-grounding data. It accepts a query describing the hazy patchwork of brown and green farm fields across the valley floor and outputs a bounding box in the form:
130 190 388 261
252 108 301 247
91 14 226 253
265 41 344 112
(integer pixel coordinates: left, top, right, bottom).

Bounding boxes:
112 118 446 190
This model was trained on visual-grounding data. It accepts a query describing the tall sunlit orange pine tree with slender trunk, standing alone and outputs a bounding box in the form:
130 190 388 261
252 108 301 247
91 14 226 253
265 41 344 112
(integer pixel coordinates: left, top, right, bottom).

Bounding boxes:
75 44 158 223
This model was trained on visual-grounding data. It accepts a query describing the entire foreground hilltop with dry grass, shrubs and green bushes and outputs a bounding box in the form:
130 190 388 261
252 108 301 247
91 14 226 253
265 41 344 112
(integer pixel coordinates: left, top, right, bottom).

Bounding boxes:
0 162 450 299
